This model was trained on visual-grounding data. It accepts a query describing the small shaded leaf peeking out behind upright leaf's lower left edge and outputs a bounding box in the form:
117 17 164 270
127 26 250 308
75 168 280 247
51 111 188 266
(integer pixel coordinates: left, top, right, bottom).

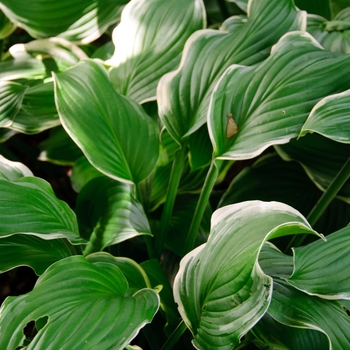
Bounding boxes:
70 156 103 193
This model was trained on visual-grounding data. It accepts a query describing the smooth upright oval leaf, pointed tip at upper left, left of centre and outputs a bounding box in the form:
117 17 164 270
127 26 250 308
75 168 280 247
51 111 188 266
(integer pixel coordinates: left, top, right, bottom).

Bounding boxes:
54 60 159 184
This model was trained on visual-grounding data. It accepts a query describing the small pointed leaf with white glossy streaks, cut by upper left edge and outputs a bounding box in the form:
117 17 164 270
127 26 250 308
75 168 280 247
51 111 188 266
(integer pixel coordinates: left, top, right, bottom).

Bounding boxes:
0 81 27 127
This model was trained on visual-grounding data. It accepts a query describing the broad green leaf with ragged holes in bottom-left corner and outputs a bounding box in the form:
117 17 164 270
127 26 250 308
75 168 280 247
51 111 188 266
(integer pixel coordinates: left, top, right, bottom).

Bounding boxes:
0 256 159 350
